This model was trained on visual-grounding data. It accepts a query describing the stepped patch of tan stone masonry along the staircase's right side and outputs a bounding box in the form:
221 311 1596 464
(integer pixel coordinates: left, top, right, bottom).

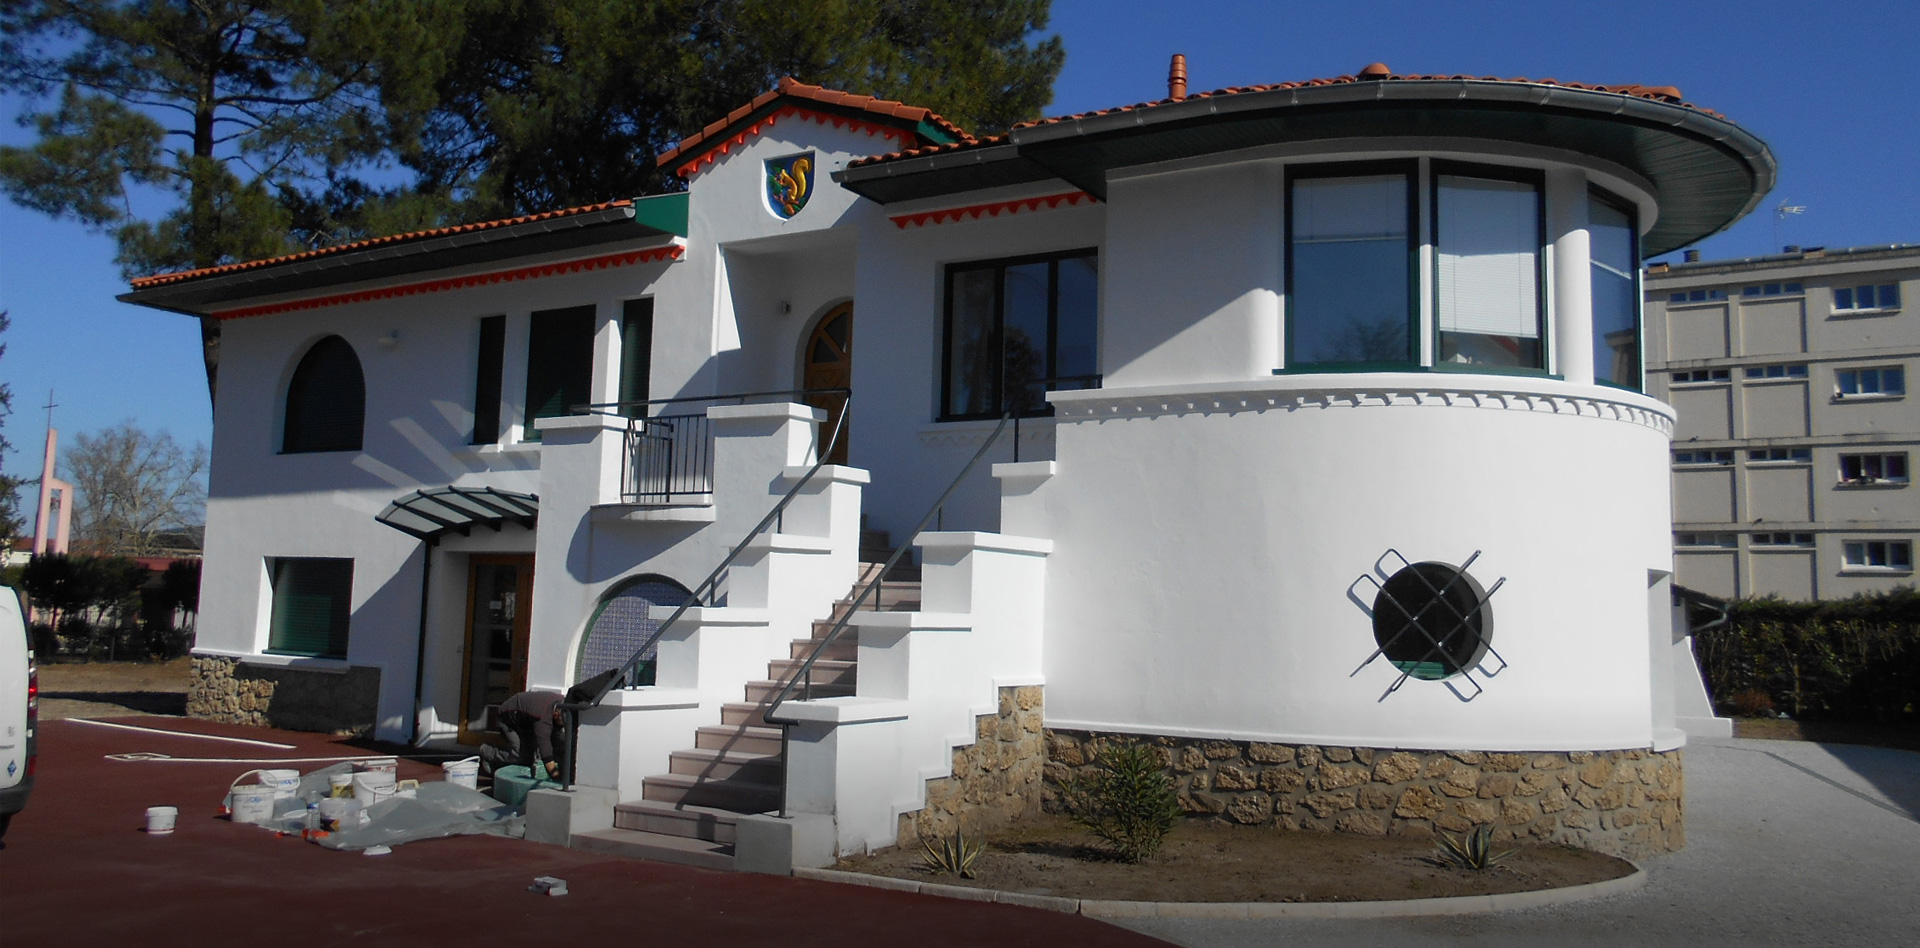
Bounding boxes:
899 685 1046 846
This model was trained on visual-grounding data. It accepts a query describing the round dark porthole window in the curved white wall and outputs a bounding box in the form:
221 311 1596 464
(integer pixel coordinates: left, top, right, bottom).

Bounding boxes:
1373 562 1492 681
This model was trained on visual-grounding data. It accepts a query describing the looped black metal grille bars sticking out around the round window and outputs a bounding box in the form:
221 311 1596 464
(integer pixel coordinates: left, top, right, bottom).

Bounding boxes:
1354 549 1507 700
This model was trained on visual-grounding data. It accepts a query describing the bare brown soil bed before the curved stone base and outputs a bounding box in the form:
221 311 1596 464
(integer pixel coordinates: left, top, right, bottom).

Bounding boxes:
835 816 1634 902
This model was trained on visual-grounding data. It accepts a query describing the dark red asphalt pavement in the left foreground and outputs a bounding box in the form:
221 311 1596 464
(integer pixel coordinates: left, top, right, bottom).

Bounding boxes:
0 718 1165 948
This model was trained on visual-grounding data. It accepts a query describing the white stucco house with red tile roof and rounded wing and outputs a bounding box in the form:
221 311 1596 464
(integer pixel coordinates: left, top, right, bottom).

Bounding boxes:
123 63 1774 867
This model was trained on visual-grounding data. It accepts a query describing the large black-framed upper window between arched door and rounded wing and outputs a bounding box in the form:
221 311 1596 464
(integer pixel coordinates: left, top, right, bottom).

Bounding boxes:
941 249 1100 420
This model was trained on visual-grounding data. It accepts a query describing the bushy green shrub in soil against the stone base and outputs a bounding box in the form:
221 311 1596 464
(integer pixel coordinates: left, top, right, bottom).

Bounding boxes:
1064 745 1181 862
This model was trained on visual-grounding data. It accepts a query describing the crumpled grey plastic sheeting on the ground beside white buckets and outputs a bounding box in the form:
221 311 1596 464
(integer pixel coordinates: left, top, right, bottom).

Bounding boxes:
263 764 526 850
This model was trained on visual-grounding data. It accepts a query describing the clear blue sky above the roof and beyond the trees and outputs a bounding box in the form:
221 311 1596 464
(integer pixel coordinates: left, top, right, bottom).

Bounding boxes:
0 0 1920 495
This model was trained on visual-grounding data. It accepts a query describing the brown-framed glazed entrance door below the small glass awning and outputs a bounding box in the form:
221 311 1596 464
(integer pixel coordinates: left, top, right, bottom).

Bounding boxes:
461 553 534 745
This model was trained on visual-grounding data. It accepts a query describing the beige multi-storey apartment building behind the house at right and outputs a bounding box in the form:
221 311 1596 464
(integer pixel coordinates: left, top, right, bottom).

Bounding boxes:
1645 244 1920 599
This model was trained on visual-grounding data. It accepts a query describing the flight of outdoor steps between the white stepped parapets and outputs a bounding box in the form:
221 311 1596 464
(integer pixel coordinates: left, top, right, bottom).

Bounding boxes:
572 530 920 869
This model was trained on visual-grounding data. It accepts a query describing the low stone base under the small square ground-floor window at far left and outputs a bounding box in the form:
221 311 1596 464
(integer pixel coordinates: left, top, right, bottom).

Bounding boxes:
186 654 380 733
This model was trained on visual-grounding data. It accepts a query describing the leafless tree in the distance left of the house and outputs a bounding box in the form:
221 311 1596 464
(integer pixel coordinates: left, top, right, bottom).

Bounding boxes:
61 420 207 557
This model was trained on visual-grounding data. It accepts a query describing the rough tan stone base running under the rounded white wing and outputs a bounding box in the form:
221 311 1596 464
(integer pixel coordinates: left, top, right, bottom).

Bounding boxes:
1036 718 1686 858
